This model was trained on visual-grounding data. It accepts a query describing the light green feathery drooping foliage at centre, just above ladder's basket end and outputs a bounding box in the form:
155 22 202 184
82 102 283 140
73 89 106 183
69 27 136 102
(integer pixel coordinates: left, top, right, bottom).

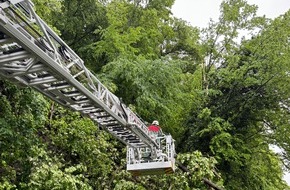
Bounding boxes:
102 58 194 137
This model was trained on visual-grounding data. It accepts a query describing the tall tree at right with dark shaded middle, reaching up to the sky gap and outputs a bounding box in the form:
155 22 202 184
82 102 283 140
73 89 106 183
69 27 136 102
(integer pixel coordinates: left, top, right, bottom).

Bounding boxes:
183 0 289 189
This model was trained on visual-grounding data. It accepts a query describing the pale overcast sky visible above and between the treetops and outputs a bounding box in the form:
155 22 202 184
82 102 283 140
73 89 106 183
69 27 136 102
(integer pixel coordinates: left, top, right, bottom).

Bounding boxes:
172 0 290 185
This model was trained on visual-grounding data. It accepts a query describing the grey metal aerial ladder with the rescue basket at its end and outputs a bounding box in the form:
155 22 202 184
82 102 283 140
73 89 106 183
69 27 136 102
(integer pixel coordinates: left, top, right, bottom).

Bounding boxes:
0 0 175 175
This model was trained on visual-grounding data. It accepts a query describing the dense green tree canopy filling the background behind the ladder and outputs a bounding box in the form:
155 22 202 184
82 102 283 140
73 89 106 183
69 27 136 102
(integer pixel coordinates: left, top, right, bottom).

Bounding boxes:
0 0 290 190
